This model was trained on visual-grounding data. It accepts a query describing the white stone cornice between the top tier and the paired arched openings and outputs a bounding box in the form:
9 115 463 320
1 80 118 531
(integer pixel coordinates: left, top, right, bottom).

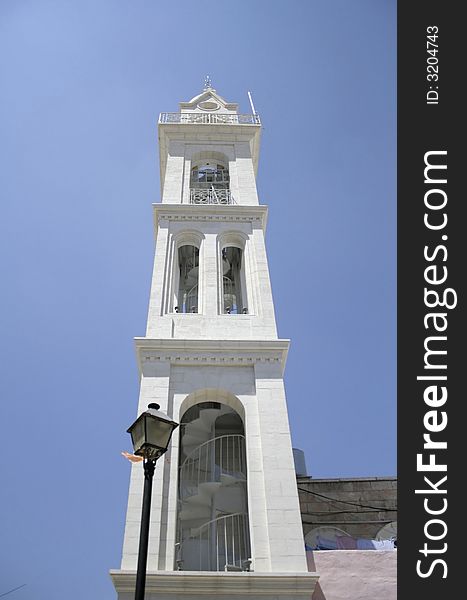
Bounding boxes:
153 202 268 231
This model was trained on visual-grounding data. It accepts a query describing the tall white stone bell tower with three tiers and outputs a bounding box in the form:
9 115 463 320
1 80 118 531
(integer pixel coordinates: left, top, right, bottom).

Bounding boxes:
111 78 317 600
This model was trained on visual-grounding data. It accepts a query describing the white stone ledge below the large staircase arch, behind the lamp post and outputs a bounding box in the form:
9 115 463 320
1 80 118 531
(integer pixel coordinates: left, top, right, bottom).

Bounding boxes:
110 570 319 600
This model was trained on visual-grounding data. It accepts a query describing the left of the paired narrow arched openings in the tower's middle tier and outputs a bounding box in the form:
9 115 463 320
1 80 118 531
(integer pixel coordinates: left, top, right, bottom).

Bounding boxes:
175 245 199 313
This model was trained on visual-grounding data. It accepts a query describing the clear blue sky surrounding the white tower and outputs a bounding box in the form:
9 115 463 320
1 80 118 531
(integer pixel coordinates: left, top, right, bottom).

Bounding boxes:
0 0 396 600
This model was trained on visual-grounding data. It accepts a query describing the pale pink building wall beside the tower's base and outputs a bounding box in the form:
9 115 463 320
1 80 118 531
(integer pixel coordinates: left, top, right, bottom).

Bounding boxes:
306 550 397 600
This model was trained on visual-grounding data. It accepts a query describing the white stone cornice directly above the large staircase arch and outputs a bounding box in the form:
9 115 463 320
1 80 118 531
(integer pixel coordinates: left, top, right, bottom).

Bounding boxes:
135 337 290 372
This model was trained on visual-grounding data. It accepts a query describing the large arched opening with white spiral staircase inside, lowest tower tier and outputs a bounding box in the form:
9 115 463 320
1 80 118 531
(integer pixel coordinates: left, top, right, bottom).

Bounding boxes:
176 402 250 571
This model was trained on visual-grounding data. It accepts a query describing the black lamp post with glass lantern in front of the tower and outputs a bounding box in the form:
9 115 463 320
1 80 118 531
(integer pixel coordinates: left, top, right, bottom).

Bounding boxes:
127 403 178 600
